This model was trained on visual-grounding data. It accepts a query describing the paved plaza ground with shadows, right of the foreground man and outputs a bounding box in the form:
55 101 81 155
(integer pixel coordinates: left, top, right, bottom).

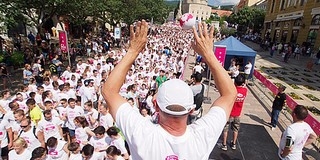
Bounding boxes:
184 42 320 160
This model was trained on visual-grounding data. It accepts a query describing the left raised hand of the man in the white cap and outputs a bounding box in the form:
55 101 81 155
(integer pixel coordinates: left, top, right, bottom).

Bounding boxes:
129 20 148 53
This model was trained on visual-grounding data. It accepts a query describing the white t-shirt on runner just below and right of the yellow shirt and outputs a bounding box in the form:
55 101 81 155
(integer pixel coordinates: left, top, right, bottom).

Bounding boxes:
38 117 62 142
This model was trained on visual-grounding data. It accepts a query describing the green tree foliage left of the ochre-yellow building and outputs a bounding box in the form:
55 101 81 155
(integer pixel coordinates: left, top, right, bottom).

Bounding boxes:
228 7 265 31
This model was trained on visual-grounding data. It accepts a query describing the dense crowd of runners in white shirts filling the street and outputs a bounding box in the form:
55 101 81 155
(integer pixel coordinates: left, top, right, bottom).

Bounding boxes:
0 24 193 160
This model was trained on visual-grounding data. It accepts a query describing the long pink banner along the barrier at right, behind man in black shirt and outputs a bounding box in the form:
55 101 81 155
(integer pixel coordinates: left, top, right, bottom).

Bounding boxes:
253 70 320 135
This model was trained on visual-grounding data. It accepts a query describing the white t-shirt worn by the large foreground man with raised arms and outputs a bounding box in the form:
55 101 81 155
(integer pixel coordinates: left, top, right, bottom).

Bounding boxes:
116 103 226 160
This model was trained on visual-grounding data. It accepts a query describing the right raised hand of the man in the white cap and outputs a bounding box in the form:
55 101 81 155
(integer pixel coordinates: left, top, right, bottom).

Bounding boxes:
192 23 214 59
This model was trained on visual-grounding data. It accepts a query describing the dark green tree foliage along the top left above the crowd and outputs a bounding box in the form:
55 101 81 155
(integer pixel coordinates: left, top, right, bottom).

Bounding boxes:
0 0 169 33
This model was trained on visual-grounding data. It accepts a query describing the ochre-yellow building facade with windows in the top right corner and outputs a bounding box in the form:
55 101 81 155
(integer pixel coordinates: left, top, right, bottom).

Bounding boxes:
262 0 320 48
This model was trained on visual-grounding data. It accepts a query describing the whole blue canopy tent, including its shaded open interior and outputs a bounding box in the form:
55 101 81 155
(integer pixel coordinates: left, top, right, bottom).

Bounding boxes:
214 36 256 78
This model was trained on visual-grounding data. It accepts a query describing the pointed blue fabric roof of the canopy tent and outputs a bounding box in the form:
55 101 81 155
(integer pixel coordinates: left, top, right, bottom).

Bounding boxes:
214 36 256 57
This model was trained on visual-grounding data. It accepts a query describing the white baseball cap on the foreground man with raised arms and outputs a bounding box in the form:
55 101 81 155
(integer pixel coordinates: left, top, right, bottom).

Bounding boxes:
156 79 196 116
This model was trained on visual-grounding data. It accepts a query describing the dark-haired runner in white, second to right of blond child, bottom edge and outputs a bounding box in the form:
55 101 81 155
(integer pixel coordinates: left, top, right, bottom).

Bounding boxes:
47 137 69 160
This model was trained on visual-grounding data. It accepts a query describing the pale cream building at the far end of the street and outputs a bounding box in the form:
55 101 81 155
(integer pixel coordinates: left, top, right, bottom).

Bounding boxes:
182 0 211 21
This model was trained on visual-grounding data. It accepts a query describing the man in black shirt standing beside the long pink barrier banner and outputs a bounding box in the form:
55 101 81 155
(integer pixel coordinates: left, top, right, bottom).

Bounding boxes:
270 86 286 130
